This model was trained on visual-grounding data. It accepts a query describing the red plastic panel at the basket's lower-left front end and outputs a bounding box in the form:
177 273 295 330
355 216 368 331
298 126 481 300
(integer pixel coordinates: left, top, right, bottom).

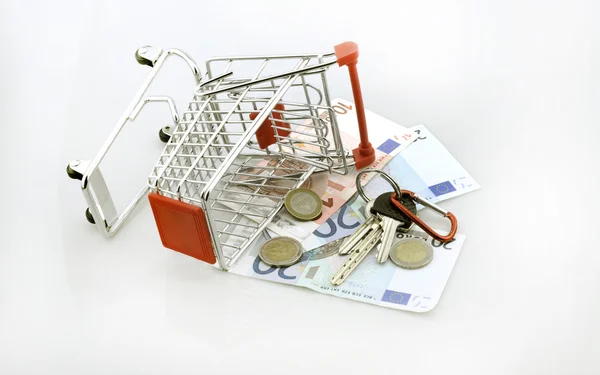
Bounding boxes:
148 193 217 264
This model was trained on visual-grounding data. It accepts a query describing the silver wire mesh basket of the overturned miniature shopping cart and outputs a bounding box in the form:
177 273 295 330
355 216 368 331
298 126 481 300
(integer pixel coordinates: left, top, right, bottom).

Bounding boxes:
149 55 347 269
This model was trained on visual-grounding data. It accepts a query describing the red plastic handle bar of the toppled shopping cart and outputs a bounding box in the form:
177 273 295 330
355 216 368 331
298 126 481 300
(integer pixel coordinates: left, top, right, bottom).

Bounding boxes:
334 42 375 170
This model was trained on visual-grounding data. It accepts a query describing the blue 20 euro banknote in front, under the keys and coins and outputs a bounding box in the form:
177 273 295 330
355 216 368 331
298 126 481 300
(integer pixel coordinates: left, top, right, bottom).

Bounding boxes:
230 228 465 312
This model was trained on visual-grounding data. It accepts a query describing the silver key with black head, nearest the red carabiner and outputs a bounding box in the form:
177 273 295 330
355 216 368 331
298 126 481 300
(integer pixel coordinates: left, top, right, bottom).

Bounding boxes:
371 193 417 263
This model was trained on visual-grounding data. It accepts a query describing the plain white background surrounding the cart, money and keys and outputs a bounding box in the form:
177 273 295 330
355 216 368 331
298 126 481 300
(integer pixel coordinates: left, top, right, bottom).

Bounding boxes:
0 0 600 374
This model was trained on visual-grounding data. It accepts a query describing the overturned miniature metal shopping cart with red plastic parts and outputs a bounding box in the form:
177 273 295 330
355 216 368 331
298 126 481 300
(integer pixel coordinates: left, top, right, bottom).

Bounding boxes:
67 42 375 269
